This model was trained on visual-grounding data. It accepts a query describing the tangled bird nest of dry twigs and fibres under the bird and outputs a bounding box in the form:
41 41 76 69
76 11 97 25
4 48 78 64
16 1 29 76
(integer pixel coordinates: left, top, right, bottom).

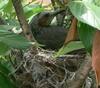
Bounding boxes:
11 49 95 88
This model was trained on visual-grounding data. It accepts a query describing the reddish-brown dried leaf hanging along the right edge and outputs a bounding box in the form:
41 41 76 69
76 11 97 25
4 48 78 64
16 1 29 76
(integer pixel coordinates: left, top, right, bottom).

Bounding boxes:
92 30 100 88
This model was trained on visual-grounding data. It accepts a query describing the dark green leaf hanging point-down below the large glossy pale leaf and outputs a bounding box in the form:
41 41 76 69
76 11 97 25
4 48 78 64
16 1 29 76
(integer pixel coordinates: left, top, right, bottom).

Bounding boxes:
78 22 95 53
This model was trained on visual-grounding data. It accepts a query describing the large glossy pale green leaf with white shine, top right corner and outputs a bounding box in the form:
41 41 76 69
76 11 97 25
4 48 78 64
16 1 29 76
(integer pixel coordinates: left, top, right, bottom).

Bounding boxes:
68 0 100 29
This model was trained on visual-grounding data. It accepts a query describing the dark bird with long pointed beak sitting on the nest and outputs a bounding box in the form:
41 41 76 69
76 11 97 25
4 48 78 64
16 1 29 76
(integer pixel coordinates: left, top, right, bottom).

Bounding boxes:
29 10 67 50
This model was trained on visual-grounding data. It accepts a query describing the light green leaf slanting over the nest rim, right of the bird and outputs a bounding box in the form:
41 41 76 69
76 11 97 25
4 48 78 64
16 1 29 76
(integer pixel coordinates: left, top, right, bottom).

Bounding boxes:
54 41 84 57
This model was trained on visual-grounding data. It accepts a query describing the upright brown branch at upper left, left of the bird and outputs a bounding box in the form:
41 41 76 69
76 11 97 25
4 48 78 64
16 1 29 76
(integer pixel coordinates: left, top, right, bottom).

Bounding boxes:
12 0 35 41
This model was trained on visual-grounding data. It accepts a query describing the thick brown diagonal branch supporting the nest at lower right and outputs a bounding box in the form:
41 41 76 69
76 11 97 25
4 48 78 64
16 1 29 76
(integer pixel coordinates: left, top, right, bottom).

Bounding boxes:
68 56 92 88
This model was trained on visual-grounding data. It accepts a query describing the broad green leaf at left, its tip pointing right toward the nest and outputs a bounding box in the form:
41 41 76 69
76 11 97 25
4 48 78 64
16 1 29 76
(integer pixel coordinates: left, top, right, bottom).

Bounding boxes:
1 34 31 49
